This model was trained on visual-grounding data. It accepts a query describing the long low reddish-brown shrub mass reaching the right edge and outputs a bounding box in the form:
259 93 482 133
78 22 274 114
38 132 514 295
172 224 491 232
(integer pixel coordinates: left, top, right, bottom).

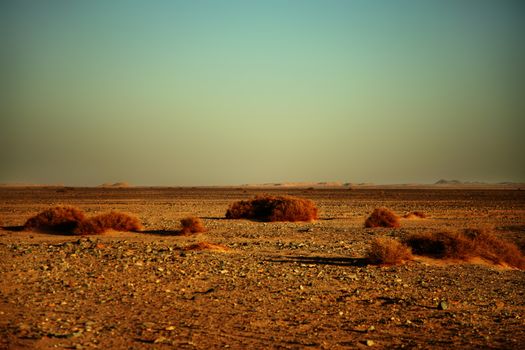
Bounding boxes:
404 228 525 269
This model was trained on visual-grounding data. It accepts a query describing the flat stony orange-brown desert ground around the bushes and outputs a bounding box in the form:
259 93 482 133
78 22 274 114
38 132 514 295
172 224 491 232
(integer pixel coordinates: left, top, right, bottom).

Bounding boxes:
0 187 525 349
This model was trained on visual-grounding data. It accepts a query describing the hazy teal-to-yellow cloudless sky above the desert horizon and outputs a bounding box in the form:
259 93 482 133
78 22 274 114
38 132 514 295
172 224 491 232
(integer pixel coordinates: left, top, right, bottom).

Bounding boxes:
0 0 525 185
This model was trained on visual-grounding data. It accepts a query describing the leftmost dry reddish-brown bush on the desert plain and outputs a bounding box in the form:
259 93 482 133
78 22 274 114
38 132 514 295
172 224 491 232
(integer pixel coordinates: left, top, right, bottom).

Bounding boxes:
24 206 85 233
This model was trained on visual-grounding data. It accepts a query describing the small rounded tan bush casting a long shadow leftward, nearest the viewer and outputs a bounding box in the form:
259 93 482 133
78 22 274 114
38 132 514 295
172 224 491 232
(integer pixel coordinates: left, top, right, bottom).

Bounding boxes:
366 237 413 265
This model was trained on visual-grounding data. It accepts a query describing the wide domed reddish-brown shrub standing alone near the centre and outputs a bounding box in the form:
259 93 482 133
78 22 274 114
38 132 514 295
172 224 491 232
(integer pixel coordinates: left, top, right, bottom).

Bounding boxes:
226 195 317 222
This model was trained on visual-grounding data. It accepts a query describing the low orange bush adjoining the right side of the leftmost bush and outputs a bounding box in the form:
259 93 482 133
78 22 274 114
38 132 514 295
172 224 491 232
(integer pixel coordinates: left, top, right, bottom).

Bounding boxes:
75 211 142 235
